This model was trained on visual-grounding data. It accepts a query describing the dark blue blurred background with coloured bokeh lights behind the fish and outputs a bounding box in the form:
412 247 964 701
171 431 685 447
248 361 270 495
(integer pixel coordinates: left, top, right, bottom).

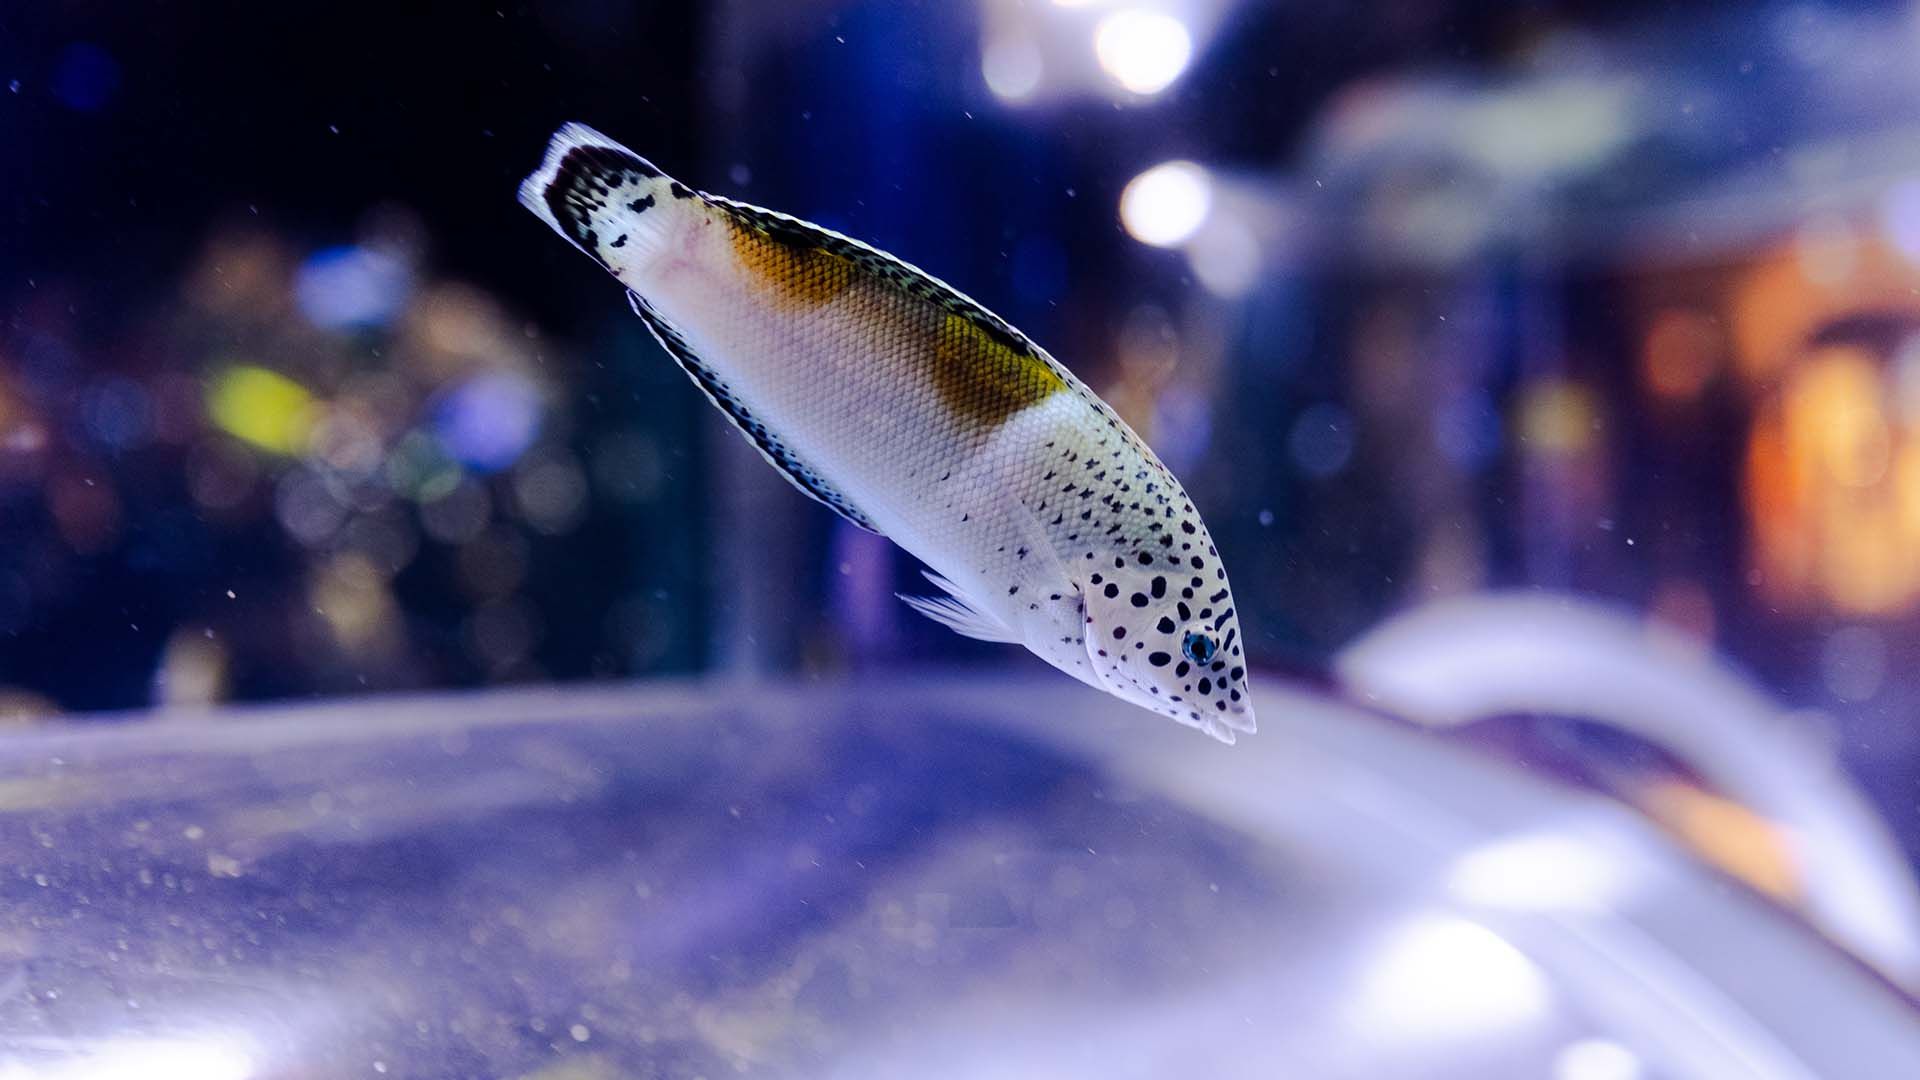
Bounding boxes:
0 0 1920 1080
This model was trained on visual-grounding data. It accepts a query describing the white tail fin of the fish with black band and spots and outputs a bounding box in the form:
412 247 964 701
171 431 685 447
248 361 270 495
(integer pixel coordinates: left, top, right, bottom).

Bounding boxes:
520 123 691 269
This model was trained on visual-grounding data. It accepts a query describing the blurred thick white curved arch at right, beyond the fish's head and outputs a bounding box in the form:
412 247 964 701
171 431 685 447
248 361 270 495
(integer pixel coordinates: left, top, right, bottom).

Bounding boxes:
1334 592 1920 988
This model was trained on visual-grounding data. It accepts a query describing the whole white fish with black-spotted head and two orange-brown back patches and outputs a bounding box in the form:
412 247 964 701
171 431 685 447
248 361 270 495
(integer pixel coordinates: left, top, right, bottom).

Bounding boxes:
518 123 1256 744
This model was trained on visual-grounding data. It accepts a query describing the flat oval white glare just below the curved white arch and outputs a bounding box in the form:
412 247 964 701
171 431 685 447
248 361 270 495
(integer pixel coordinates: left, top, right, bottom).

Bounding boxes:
1448 832 1632 911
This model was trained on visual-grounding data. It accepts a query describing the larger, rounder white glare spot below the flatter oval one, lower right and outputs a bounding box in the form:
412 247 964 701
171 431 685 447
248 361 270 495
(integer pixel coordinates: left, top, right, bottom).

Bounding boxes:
1354 915 1549 1040
